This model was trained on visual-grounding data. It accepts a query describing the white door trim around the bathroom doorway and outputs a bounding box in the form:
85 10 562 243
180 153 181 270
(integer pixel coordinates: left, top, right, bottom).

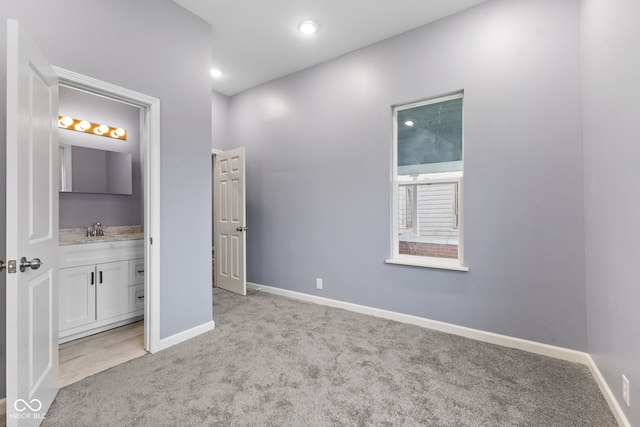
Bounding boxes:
53 67 162 353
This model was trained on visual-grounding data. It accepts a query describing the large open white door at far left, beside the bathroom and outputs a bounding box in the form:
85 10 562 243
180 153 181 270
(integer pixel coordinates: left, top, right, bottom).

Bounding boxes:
6 20 58 426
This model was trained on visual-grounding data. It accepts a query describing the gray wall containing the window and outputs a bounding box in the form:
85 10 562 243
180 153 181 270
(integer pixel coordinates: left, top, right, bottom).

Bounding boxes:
230 0 587 351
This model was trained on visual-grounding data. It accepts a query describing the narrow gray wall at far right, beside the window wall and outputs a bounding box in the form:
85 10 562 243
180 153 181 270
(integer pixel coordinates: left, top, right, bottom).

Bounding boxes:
582 0 640 426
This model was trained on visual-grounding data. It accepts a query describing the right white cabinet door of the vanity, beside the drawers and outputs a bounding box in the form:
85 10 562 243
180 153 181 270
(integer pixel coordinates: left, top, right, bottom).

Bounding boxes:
96 261 129 320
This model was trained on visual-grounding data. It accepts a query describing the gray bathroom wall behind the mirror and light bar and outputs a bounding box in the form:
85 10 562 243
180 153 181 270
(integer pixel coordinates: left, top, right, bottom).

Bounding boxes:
58 87 144 228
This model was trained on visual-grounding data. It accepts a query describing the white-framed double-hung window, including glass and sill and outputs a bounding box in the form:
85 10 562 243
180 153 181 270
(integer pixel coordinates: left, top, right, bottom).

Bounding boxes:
387 92 467 271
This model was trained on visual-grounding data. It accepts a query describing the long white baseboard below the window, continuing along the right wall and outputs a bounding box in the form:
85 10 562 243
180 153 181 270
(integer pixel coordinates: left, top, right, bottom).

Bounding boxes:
247 283 631 427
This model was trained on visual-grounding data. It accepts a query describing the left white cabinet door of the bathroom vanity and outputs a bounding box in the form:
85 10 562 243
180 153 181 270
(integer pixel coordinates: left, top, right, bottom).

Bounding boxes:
58 265 96 331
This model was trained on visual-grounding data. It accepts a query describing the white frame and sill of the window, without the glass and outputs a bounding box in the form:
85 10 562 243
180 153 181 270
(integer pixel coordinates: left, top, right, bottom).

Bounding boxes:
385 91 469 271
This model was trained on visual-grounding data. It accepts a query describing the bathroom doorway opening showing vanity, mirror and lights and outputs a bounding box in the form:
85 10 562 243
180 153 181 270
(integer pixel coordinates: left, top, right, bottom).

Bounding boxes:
58 85 146 387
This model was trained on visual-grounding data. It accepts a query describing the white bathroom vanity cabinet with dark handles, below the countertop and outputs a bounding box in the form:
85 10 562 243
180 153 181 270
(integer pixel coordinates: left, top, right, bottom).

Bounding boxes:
58 240 144 343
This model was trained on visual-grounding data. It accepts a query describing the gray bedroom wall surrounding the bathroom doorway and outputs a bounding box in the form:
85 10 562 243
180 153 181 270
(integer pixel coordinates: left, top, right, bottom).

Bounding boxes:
0 0 212 400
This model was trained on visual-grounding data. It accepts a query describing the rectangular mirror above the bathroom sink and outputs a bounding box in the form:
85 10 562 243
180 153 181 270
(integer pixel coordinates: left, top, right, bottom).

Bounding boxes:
59 144 133 195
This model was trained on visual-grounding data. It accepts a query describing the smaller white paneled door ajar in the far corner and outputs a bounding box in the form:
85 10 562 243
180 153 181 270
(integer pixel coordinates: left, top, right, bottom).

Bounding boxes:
213 147 247 295
